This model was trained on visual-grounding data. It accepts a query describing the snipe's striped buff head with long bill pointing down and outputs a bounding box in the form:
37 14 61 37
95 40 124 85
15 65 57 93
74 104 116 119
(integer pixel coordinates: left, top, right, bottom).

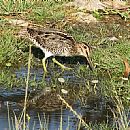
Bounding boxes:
77 43 93 70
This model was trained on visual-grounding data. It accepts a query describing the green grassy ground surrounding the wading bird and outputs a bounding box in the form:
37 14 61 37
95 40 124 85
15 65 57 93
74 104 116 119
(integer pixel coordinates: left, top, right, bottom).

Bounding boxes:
0 0 130 130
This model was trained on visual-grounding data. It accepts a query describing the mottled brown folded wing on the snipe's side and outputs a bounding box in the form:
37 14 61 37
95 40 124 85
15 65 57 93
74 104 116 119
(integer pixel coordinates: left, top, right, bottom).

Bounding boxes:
35 34 75 55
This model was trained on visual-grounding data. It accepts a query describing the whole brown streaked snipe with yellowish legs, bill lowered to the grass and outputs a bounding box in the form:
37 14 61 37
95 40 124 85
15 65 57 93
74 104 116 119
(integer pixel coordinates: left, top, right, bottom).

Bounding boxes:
20 27 93 72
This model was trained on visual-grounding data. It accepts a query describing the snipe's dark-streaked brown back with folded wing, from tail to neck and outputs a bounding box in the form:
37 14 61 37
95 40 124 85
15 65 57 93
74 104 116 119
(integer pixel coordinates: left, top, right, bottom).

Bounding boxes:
27 28 76 56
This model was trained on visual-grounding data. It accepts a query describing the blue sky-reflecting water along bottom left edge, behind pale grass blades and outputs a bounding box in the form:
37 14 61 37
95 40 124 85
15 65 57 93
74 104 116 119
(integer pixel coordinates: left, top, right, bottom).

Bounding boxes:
0 102 76 130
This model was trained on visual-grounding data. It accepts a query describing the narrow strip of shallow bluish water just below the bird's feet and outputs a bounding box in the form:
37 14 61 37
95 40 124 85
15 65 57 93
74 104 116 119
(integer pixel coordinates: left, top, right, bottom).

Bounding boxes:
15 67 87 84
